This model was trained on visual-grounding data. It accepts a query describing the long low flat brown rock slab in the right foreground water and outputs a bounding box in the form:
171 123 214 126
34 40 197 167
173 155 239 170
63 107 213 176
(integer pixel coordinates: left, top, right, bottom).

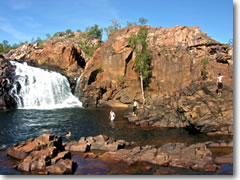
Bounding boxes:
99 143 213 171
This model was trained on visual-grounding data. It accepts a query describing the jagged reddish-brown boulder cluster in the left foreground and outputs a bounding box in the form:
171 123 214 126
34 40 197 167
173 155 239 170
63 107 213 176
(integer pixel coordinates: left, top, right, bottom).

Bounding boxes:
7 134 74 174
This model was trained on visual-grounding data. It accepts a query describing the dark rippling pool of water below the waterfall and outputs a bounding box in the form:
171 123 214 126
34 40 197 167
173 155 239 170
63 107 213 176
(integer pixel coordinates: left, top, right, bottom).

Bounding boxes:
0 108 232 174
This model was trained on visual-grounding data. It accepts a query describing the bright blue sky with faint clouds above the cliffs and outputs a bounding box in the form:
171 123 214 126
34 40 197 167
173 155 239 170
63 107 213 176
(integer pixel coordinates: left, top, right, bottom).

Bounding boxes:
0 0 233 44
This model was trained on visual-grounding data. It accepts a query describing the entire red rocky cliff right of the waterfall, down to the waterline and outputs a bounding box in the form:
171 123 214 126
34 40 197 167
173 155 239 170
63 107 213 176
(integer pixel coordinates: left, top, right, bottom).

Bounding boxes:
81 26 233 134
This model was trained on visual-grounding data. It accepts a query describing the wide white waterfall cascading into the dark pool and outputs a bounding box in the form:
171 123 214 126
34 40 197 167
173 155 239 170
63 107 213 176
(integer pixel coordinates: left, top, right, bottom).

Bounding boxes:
11 61 82 109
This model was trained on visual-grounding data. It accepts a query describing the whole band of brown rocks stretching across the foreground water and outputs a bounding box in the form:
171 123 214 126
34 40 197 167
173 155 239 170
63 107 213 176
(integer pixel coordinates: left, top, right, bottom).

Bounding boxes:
7 134 233 174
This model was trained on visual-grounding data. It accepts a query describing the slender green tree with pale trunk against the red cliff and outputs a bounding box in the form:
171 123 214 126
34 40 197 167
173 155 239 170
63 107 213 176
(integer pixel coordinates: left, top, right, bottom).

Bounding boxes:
129 27 152 105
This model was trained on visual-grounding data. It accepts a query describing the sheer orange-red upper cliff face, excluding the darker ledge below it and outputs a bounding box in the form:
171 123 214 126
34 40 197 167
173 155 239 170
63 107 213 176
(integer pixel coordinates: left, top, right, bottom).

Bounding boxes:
81 26 233 105
